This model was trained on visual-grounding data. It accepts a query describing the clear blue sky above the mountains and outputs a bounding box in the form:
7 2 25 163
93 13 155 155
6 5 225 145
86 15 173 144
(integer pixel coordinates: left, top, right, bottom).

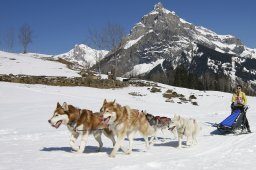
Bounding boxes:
0 0 256 55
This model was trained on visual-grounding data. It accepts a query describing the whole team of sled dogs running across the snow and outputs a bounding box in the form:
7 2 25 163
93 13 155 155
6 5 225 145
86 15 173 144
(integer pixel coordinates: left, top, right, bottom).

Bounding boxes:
48 99 200 157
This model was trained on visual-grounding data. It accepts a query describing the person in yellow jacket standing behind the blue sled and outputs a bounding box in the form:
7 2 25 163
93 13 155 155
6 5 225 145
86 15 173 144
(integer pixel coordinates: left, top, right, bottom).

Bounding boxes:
231 85 251 133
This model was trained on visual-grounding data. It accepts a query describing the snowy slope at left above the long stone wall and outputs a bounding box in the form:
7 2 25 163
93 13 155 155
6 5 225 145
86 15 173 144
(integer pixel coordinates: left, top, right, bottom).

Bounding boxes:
0 51 79 77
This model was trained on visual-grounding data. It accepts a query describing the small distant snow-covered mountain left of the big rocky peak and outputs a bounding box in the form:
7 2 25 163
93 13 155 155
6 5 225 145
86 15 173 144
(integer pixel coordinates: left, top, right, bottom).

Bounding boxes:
54 44 108 67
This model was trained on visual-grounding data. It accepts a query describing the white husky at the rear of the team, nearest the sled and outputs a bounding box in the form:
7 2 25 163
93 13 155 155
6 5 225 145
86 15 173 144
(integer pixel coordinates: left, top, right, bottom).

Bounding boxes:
169 115 200 148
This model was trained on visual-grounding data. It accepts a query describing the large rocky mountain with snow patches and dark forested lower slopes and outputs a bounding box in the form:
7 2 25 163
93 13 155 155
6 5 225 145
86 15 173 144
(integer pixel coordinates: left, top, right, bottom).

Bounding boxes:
101 3 256 94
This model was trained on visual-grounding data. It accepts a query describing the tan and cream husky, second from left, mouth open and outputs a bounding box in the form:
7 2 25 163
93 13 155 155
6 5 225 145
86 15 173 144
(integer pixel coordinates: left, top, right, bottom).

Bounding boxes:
100 99 154 157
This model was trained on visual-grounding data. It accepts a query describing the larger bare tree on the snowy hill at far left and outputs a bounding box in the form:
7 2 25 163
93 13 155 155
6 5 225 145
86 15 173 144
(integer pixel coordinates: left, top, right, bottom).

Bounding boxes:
19 24 32 53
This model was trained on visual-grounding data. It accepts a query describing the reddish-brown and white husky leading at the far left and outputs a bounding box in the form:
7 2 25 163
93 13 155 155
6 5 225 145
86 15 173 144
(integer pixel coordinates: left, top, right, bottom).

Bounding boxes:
48 102 115 153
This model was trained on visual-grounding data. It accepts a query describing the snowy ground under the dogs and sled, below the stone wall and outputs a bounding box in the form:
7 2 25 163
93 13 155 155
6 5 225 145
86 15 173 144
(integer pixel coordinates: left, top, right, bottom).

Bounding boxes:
0 82 256 170
